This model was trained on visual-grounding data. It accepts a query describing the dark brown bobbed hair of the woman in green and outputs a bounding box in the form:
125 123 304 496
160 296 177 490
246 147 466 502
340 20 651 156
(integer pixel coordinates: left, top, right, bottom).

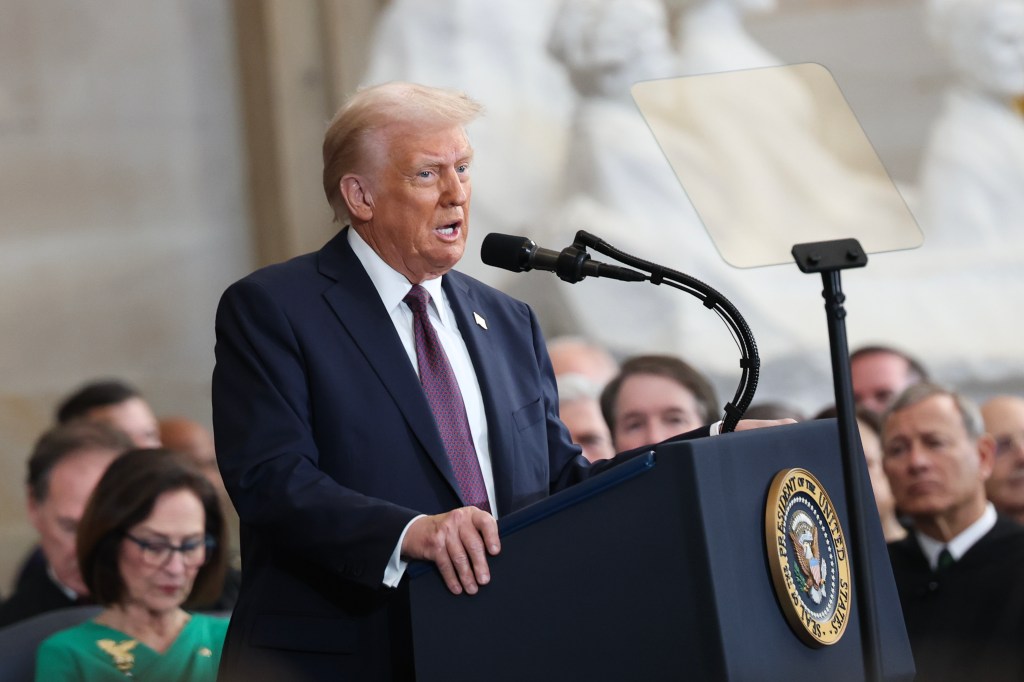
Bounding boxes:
77 447 227 607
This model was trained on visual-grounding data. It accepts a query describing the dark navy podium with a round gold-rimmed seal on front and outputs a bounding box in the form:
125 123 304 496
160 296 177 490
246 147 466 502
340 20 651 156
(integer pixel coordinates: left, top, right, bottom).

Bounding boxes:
409 420 913 682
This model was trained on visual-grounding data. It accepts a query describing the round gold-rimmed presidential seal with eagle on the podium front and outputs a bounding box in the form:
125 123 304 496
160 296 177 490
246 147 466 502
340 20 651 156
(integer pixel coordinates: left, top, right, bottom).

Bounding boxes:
765 469 851 646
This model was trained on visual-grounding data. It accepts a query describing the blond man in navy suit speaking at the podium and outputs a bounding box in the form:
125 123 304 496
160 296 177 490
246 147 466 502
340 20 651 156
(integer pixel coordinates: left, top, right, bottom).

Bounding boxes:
213 83 778 680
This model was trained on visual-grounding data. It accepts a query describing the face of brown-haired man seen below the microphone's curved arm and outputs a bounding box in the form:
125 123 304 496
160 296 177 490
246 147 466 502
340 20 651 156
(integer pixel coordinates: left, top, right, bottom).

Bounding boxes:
612 374 703 452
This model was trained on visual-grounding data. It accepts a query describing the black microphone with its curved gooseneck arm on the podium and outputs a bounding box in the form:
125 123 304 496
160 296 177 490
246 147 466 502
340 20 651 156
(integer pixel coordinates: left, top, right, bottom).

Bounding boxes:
480 229 761 433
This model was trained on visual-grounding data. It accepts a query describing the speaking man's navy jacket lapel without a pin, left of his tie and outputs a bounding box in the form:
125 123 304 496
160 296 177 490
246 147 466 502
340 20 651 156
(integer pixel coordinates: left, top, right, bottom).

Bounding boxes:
318 229 459 495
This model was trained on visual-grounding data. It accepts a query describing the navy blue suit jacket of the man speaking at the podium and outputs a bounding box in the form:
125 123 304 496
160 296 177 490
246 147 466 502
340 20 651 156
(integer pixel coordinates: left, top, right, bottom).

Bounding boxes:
213 230 603 680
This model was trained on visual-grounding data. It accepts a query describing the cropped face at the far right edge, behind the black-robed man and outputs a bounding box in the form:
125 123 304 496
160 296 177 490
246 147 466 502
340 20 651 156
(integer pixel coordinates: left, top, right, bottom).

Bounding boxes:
981 395 1024 521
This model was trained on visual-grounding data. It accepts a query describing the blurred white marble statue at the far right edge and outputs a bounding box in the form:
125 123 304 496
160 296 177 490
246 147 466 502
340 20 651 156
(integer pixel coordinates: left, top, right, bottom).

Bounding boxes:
835 0 1024 392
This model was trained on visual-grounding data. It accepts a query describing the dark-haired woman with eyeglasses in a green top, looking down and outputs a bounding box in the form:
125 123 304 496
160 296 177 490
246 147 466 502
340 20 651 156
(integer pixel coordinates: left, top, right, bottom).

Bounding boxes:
36 450 227 682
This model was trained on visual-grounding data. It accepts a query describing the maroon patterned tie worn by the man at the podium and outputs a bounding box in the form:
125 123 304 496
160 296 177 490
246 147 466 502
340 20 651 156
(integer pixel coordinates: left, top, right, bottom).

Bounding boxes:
402 285 490 511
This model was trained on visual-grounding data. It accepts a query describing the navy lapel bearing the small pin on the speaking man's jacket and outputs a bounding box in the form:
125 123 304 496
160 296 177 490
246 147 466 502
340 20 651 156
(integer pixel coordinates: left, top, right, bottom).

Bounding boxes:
441 273 515 515
